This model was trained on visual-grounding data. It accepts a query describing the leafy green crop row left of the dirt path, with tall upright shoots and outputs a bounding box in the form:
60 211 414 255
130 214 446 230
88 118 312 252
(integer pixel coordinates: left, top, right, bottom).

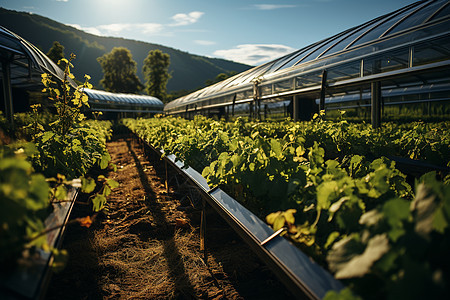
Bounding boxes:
0 55 117 267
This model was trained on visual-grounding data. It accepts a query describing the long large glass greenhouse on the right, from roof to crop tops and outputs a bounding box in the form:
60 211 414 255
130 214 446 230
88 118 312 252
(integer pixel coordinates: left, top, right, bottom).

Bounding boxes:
164 1 450 127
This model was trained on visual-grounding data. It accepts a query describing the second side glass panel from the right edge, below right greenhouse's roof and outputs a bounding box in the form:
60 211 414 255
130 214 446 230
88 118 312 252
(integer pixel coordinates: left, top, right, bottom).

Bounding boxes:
364 48 409 76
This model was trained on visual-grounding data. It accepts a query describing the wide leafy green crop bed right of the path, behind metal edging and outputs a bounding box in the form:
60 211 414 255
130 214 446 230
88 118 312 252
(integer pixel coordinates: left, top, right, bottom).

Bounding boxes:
123 116 450 299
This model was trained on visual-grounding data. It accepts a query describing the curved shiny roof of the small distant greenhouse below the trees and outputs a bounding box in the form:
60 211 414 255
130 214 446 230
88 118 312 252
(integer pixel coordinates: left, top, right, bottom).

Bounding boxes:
84 89 164 110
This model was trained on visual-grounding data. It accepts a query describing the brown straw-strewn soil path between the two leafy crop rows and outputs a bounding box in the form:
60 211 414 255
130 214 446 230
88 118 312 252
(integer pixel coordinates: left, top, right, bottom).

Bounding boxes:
46 137 291 299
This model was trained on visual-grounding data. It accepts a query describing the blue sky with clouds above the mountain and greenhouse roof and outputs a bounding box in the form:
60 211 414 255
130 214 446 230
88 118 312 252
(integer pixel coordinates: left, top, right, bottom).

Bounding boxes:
0 0 415 65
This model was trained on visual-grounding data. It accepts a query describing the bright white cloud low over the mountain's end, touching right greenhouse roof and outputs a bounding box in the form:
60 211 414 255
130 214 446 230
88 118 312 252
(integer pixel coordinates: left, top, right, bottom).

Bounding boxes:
214 44 295 66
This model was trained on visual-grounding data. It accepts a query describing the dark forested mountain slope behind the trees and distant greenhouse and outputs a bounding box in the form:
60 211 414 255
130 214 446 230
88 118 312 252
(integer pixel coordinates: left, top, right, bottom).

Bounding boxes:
0 7 250 92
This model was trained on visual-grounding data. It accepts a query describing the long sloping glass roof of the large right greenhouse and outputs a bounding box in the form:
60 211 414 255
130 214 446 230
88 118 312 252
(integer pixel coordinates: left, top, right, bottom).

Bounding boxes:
165 0 450 111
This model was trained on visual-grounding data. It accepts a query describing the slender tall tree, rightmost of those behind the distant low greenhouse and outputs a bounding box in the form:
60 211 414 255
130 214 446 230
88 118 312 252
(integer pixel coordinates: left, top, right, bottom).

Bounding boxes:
142 49 171 102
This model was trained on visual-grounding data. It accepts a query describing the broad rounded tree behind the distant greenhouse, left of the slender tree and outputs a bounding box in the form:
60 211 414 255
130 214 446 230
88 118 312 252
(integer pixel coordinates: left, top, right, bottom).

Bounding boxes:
97 47 143 93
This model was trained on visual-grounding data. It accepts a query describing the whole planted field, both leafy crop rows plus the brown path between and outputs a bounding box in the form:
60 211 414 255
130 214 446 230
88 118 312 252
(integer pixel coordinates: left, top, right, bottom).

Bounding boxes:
0 65 450 299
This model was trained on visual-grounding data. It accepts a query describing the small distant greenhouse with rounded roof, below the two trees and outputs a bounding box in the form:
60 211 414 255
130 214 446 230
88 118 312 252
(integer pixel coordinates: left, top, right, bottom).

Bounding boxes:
84 89 164 117
